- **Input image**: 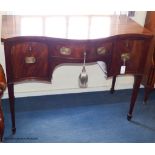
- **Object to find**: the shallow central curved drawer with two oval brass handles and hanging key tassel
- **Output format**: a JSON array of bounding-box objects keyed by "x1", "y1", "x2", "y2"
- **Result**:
[{"x1": 51, "y1": 40, "x2": 113, "y2": 60}]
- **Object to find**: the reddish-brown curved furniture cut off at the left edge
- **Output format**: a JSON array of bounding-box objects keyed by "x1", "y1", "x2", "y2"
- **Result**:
[{"x1": 0, "y1": 64, "x2": 6, "y2": 141}]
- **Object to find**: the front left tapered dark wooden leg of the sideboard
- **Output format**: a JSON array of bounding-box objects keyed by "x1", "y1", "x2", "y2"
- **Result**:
[{"x1": 8, "y1": 84, "x2": 16, "y2": 134}]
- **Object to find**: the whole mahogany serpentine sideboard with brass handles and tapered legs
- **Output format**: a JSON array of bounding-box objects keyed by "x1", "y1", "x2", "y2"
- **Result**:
[{"x1": 2, "y1": 16, "x2": 152, "y2": 133}]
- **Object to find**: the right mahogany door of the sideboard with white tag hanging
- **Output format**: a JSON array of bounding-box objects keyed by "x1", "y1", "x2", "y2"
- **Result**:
[{"x1": 112, "y1": 39, "x2": 148, "y2": 75}]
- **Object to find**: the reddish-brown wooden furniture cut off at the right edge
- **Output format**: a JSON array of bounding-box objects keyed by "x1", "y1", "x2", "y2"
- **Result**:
[{"x1": 142, "y1": 11, "x2": 155, "y2": 103}]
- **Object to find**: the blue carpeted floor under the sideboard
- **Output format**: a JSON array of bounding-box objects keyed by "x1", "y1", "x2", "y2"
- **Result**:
[{"x1": 3, "y1": 89, "x2": 155, "y2": 143}]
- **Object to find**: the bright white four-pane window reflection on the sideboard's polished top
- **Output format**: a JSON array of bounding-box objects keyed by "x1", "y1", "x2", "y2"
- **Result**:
[{"x1": 19, "y1": 15, "x2": 128, "y2": 39}]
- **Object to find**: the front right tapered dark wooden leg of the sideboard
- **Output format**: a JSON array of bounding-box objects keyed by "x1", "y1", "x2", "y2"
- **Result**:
[{"x1": 127, "y1": 75, "x2": 142, "y2": 121}]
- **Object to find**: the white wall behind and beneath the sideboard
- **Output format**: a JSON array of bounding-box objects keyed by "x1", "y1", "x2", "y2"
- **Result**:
[{"x1": 0, "y1": 12, "x2": 146, "y2": 98}]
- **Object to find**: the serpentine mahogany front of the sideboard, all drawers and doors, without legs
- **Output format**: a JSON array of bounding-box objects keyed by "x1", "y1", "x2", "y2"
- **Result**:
[{"x1": 3, "y1": 35, "x2": 151, "y2": 81}]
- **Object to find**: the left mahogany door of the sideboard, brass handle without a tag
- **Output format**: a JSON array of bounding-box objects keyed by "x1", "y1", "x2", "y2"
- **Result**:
[{"x1": 11, "y1": 42, "x2": 49, "y2": 82}]
